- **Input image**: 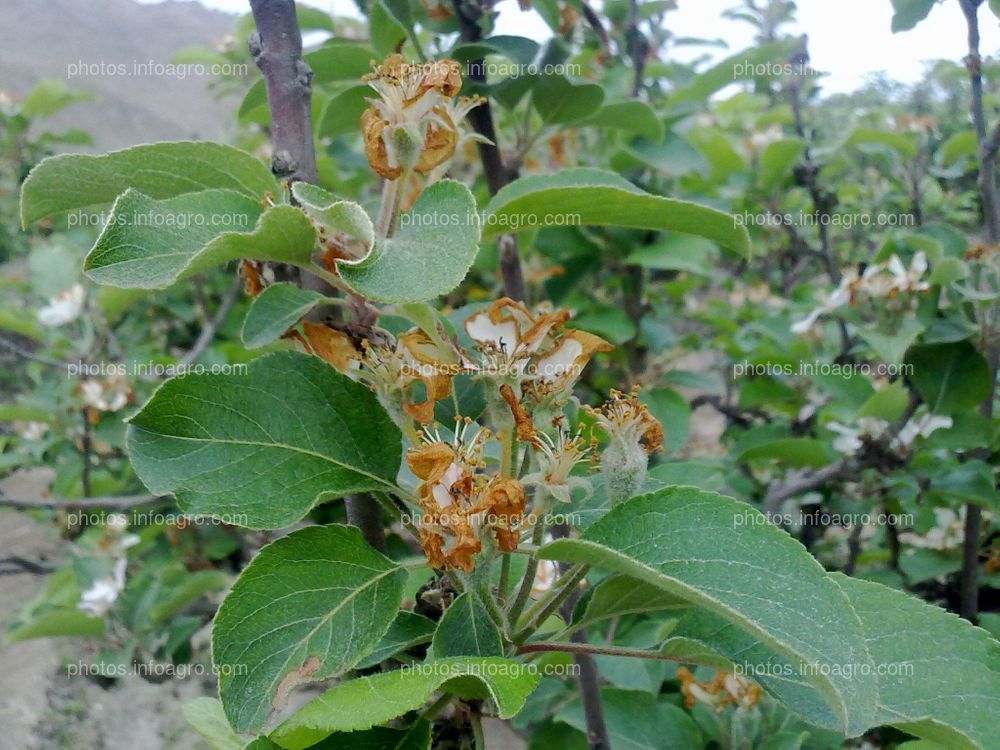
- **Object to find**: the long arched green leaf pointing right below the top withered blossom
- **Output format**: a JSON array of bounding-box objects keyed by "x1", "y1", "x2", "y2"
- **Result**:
[{"x1": 483, "y1": 168, "x2": 750, "y2": 257}]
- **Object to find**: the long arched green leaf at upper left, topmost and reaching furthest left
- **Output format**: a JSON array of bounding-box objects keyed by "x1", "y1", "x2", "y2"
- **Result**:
[{"x1": 21, "y1": 141, "x2": 278, "y2": 226}]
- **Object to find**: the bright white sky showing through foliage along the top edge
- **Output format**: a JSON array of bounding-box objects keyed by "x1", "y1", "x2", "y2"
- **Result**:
[{"x1": 142, "y1": 0, "x2": 1000, "y2": 93}]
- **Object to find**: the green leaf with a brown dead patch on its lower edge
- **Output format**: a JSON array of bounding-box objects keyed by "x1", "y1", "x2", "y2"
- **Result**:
[{"x1": 212, "y1": 525, "x2": 406, "y2": 732}]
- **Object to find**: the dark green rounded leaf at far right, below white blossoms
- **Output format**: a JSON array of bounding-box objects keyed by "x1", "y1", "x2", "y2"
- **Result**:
[{"x1": 906, "y1": 341, "x2": 991, "y2": 414}]
